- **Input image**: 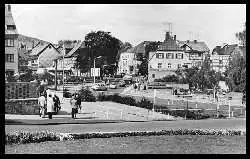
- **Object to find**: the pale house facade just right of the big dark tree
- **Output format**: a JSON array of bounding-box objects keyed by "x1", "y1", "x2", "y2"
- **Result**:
[{"x1": 117, "y1": 52, "x2": 140, "y2": 74}]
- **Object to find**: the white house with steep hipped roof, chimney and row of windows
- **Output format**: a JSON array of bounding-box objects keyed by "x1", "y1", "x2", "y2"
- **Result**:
[{"x1": 148, "y1": 32, "x2": 187, "y2": 82}]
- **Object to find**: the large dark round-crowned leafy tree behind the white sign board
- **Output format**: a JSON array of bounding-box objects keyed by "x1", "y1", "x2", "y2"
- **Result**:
[{"x1": 75, "y1": 31, "x2": 121, "y2": 74}]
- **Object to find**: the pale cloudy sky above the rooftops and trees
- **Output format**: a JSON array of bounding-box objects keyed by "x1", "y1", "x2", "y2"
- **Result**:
[{"x1": 12, "y1": 4, "x2": 246, "y2": 50}]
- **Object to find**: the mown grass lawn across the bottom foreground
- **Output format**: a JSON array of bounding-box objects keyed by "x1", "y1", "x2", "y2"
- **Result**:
[{"x1": 5, "y1": 135, "x2": 246, "y2": 154}]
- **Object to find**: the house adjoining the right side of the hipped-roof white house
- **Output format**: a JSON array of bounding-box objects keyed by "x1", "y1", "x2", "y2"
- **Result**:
[{"x1": 178, "y1": 40, "x2": 210, "y2": 67}]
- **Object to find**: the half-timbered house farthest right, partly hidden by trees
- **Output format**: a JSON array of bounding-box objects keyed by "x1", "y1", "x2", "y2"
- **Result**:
[{"x1": 210, "y1": 44, "x2": 246, "y2": 73}]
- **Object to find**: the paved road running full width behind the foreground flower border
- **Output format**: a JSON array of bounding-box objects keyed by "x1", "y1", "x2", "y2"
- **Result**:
[{"x1": 5, "y1": 119, "x2": 246, "y2": 133}]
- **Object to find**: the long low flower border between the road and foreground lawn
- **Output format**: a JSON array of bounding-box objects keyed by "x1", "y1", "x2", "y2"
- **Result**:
[{"x1": 5, "y1": 129, "x2": 246, "y2": 144}]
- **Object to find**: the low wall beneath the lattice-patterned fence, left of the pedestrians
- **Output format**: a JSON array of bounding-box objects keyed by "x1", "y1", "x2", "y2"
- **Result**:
[{"x1": 5, "y1": 98, "x2": 39, "y2": 115}]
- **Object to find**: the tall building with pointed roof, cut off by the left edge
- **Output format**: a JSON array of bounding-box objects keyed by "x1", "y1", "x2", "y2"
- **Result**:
[{"x1": 5, "y1": 5, "x2": 18, "y2": 76}]
